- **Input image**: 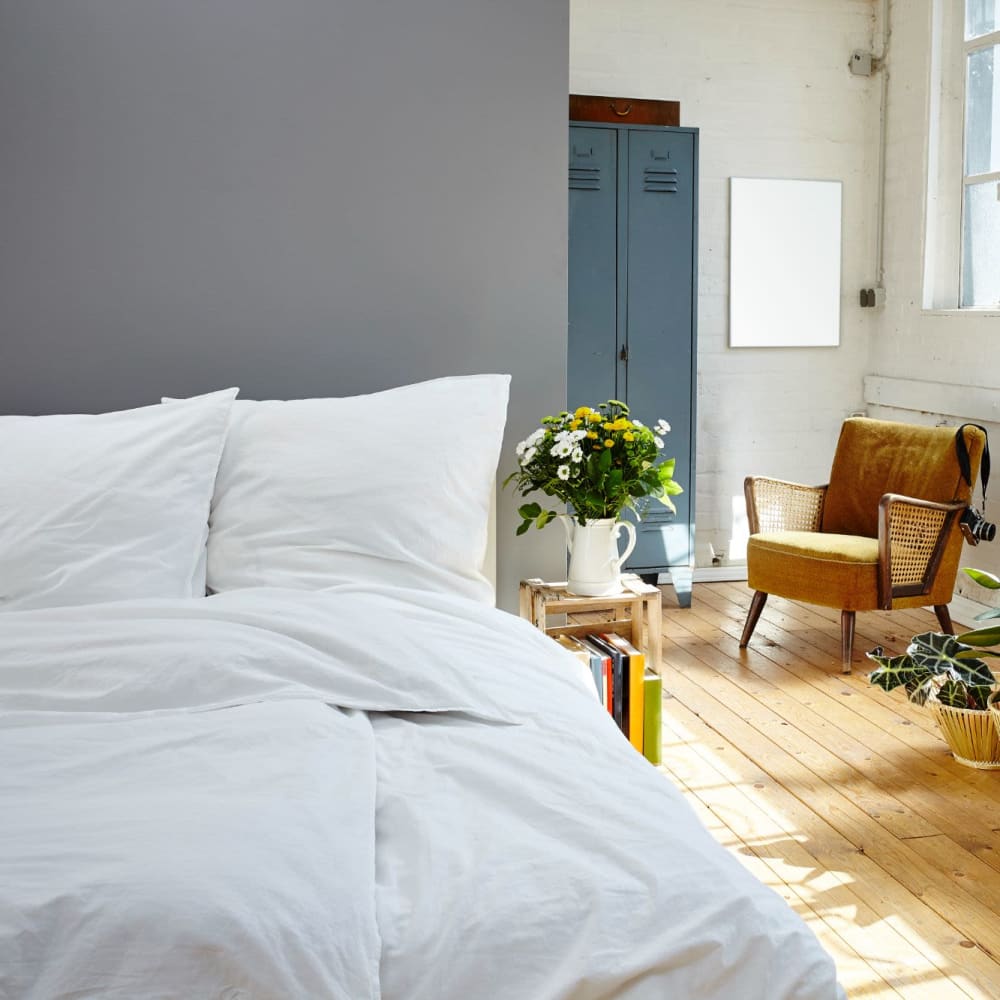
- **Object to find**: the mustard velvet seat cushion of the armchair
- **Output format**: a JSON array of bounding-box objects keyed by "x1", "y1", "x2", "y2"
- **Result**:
[{"x1": 747, "y1": 531, "x2": 878, "y2": 611}]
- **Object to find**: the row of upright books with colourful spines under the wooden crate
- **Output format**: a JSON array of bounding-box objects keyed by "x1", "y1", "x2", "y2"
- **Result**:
[{"x1": 556, "y1": 631, "x2": 663, "y2": 764}]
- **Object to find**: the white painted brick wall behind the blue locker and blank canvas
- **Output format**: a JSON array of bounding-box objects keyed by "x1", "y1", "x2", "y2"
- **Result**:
[{"x1": 570, "y1": 0, "x2": 878, "y2": 564}]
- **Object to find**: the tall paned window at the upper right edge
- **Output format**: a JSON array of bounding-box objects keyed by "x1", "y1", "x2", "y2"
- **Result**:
[{"x1": 959, "y1": 0, "x2": 1000, "y2": 307}]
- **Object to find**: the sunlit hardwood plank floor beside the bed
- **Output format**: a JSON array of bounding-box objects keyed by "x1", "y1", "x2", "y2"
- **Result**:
[{"x1": 648, "y1": 583, "x2": 1000, "y2": 1000}]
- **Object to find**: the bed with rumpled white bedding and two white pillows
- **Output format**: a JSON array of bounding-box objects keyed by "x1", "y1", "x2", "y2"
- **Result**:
[{"x1": 0, "y1": 375, "x2": 843, "y2": 1000}]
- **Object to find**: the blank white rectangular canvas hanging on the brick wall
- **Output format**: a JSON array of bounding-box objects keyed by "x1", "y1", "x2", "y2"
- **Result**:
[{"x1": 729, "y1": 177, "x2": 842, "y2": 347}]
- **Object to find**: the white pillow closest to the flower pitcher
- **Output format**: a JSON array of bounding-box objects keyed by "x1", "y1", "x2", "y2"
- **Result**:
[{"x1": 208, "y1": 375, "x2": 510, "y2": 603}]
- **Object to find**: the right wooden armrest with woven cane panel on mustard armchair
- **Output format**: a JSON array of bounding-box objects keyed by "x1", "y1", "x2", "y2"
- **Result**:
[{"x1": 878, "y1": 493, "x2": 966, "y2": 611}]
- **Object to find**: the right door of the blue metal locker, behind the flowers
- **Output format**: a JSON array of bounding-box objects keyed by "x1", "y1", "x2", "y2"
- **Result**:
[{"x1": 622, "y1": 130, "x2": 696, "y2": 584}]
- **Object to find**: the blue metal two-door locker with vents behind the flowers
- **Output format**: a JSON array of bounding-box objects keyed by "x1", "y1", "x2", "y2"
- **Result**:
[{"x1": 568, "y1": 124, "x2": 698, "y2": 607}]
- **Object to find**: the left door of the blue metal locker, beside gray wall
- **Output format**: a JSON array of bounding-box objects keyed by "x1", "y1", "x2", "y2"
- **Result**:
[{"x1": 567, "y1": 125, "x2": 619, "y2": 407}]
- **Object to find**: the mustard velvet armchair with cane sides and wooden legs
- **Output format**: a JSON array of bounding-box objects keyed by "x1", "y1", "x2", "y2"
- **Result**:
[{"x1": 740, "y1": 417, "x2": 986, "y2": 674}]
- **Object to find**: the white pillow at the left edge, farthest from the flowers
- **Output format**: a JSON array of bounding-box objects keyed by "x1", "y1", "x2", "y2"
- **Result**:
[{"x1": 0, "y1": 389, "x2": 239, "y2": 610}]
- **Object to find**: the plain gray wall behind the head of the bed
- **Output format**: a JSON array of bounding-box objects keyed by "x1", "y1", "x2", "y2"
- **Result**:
[{"x1": 0, "y1": 0, "x2": 568, "y2": 607}]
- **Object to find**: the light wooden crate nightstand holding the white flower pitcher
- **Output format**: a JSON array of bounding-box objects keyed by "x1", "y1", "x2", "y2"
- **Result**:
[{"x1": 521, "y1": 573, "x2": 661, "y2": 673}]
